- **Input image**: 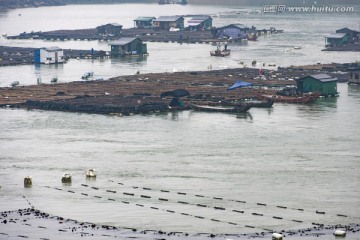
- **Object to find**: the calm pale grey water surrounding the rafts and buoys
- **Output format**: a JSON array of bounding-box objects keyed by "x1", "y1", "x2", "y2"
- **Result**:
[{"x1": 0, "y1": 4, "x2": 360, "y2": 233}]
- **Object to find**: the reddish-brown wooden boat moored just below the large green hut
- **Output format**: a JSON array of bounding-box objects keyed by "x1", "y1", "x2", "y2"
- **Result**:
[{"x1": 258, "y1": 93, "x2": 320, "y2": 104}]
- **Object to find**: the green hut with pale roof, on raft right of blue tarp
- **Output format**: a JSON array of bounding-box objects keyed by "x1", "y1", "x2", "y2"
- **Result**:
[{"x1": 296, "y1": 73, "x2": 338, "y2": 97}]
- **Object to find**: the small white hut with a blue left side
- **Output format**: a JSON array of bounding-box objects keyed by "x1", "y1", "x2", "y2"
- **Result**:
[{"x1": 34, "y1": 46, "x2": 65, "y2": 64}]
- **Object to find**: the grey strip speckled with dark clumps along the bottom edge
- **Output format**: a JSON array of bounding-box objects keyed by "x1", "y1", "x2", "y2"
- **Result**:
[{"x1": 0, "y1": 207, "x2": 360, "y2": 240}]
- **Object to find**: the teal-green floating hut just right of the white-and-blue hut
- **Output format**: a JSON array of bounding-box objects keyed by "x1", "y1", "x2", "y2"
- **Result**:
[{"x1": 109, "y1": 37, "x2": 148, "y2": 57}]
